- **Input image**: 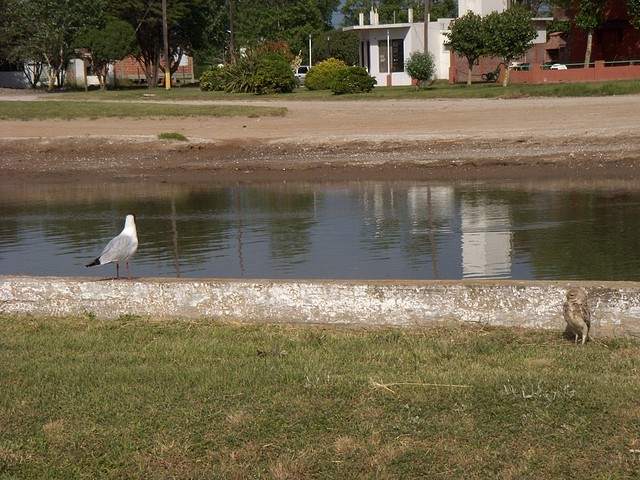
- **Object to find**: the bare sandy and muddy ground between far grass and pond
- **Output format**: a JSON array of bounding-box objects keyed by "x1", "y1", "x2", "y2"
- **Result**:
[{"x1": 0, "y1": 92, "x2": 640, "y2": 183}]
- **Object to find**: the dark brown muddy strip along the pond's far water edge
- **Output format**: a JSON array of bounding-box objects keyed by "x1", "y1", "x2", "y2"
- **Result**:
[{"x1": 0, "y1": 136, "x2": 640, "y2": 183}]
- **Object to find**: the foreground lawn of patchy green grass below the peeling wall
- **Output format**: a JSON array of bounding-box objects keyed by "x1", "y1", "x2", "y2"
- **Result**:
[{"x1": 0, "y1": 316, "x2": 640, "y2": 479}]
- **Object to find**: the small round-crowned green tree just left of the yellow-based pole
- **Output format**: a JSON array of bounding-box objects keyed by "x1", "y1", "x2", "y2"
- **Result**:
[{"x1": 74, "y1": 20, "x2": 136, "y2": 90}]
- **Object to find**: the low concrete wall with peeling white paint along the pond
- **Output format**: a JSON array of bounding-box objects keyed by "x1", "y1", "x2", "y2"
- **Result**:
[{"x1": 0, "y1": 276, "x2": 640, "y2": 336}]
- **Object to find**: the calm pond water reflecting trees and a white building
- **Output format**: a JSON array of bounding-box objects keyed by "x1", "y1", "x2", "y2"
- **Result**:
[{"x1": 0, "y1": 180, "x2": 640, "y2": 280}]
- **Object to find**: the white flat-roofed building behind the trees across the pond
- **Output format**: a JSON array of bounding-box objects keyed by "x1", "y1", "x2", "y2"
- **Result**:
[{"x1": 344, "y1": 0, "x2": 551, "y2": 86}]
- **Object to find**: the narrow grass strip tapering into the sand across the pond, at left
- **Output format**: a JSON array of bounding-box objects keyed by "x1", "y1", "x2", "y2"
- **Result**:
[{"x1": 0, "y1": 100, "x2": 286, "y2": 120}]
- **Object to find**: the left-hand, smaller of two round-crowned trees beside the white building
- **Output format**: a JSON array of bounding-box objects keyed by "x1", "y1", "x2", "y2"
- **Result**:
[{"x1": 445, "y1": 11, "x2": 486, "y2": 85}]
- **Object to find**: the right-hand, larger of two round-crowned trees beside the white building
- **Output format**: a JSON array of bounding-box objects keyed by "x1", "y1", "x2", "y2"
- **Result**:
[{"x1": 482, "y1": 5, "x2": 537, "y2": 87}]
